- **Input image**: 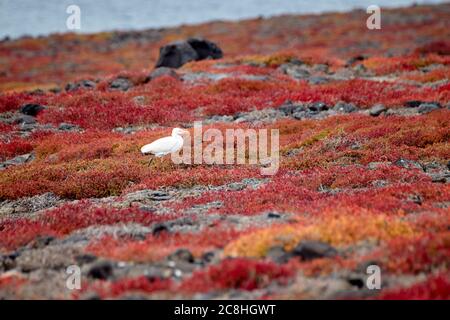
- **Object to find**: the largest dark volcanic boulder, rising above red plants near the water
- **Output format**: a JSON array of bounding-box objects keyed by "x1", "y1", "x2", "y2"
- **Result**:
[{"x1": 156, "y1": 38, "x2": 223, "y2": 68}]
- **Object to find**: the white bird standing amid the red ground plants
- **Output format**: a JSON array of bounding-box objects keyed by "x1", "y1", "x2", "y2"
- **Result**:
[{"x1": 141, "y1": 128, "x2": 189, "y2": 165}]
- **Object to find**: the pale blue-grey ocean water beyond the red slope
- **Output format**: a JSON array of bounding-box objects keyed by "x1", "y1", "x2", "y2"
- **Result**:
[{"x1": 0, "y1": 0, "x2": 444, "y2": 38}]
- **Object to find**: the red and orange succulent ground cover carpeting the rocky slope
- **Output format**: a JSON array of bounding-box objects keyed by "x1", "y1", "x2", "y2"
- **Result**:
[{"x1": 0, "y1": 4, "x2": 450, "y2": 299}]
